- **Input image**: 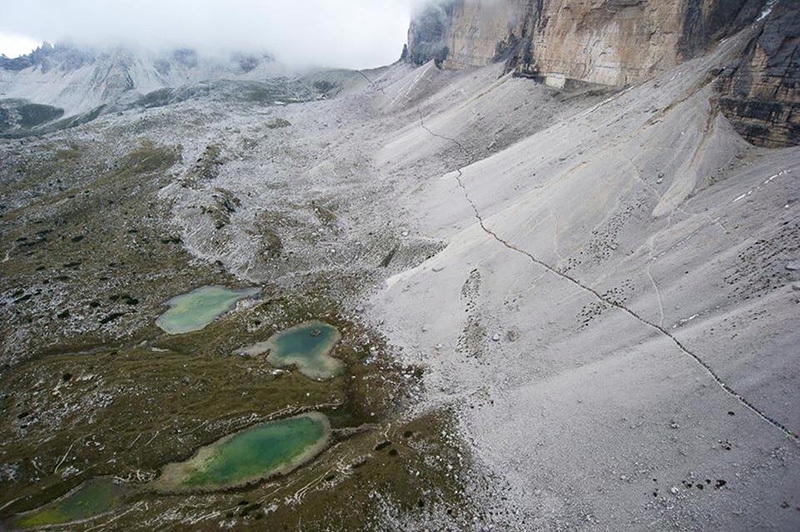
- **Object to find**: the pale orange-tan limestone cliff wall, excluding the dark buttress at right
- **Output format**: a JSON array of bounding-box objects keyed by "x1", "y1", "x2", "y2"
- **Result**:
[{"x1": 409, "y1": 0, "x2": 767, "y2": 85}]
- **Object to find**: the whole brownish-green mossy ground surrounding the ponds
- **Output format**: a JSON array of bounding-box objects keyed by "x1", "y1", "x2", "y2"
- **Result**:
[{"x1": 0, "y1": 138, "x2": 476, "y2": 530}]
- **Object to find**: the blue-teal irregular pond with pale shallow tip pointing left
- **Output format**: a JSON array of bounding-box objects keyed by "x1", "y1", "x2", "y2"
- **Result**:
[{"x1": 234, "y1": 321, "x2": 344, "y2": 379}]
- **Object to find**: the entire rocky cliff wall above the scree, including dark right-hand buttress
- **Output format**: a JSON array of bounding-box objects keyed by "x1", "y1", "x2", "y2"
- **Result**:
[{"x1": 405, "y1": 0, "x2": 800, "y2": 147}]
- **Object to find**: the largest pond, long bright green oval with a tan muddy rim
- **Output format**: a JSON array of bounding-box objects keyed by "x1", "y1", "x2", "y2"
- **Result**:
[{"x1": 155, "y1": 412, "x2": 330, "y2": 491}]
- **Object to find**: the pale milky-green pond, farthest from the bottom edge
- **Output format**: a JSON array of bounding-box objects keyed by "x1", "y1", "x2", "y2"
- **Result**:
[{"x1": 156, "y1": 286, "x2": 259, "y2": 334}]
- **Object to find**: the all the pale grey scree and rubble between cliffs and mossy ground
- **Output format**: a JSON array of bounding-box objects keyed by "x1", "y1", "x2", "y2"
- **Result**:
[{"x1": 1, "y1": 23, "x2": 800, "y2": 530}]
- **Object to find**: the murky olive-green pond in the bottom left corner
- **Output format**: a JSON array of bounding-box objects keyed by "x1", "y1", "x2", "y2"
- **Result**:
[{"x1": 14, "y1": 478, "x2": 125, "y2": 528}]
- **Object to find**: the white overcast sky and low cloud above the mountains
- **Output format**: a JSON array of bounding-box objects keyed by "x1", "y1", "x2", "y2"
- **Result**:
[{"x1": 0, "y1": 0, "x2": 432, "y2": 68}]
